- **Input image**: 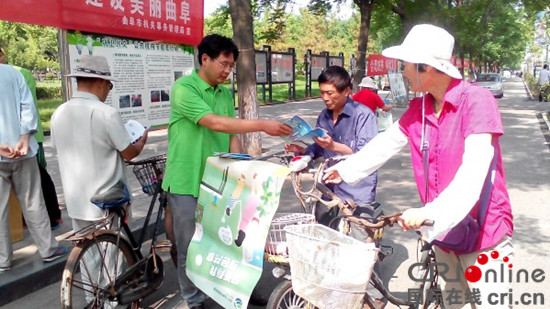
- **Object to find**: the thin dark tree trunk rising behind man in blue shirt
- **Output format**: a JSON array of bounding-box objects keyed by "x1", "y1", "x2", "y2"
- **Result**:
[{"x1": 350, "y1": 0, "x2": 374, "y2": 91}]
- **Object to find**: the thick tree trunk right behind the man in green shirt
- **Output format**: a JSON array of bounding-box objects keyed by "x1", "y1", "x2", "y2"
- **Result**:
[{"x1": 229, "y1": 0, "x2": 262, "y2": 156}]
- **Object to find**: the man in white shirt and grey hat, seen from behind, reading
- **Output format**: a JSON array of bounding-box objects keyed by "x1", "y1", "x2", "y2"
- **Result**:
[{"x1": 51, "y1": 56, "x2": 148, "y2": 230}]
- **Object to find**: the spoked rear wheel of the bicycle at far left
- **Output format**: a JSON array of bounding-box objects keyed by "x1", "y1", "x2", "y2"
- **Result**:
[{"x1": 61, "y1": 230, "x2": 138, "y2": 309}]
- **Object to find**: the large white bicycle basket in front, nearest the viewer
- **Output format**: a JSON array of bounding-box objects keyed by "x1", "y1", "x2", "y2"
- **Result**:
[{"x1": 285, "y1": 224, "x2": 378, "y2": 309}]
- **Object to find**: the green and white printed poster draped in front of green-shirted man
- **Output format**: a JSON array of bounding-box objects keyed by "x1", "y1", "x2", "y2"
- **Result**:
[{"x1": 187, "y1": 157, "x2": 290, "y2": 309}]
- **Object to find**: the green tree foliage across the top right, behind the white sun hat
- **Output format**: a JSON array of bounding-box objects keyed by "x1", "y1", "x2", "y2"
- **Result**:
[{"x1": 206, "y1": 0, "x2": 550, "y2": 70}]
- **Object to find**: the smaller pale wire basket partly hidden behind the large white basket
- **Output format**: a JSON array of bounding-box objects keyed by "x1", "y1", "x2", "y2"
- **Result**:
[{"x1": 265, "y1": 213, "x2": 315, "y2": 257}]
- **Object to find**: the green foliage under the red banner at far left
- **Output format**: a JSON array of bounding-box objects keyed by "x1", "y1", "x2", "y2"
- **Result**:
[{"x1": 0, "y1": 21, "x2": 59, "y2": 70}]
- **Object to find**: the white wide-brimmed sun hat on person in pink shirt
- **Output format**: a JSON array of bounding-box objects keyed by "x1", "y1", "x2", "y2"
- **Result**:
[{"x1": 382, "y1": 24, "x2": 462, "y2": 79}]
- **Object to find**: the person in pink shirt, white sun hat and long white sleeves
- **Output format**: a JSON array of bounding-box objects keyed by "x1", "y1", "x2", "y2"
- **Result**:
[{"x1": 324, "y1": 25, "x2": 513, "y2": 308}]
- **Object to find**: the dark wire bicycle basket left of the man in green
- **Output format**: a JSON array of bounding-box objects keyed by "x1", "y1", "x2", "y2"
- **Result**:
[{"x1": 131, "y1": 154, "x2": 166, "y2": 195}]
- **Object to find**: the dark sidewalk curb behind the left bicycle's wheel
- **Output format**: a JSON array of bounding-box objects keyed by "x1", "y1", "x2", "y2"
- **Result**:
[{"x1": 0, "y1": 214, "x2": 165, "y2": 307}]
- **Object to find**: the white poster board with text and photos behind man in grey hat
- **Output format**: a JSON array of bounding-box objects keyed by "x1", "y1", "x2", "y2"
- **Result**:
[{"x1": 67, "y1": 31, "x2": 194, "y2": 127}]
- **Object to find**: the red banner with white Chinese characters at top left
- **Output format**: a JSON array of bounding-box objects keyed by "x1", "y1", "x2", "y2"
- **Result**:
[{"x1": 0, "y1": 0, "x2": 204, "y2": 46}]
